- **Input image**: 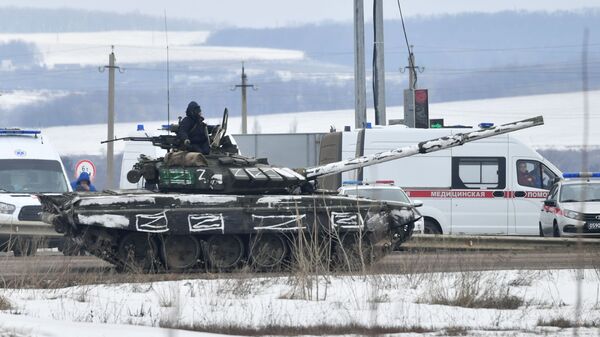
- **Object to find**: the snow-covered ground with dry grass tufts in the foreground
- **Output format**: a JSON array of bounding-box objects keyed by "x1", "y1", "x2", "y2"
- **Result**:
[{"x1": 0, "y1": 270, "x2": 600, "y2": 336}]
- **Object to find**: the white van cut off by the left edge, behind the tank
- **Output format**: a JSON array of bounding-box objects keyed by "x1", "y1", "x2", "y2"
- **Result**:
[{"x1": 0, "y1": 129, "x2": 71, "y2": 256}]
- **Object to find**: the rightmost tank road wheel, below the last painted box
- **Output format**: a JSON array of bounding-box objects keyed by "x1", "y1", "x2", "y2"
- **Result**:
[{"x1": 334, "y1": 233, "x2": 374, "y2": 271}]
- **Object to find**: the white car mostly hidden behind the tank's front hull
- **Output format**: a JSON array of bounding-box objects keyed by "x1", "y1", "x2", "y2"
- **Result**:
[{"x1": 338, "y1": 180, "x2": 425, "y2": 233}]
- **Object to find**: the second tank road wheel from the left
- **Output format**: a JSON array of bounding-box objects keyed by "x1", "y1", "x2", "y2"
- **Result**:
[{"x1": 162, "y1": 235, "x2": 200, "y2": 270}]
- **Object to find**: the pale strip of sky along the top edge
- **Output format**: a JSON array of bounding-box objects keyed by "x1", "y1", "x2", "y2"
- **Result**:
[{"x1": 0, "y1": 0, "x2": 600, "y2": 27}]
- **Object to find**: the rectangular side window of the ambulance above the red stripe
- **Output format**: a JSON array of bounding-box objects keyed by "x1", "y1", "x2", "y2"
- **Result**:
[{"x1": 452, "y1": 157, "x2": 506, "y2": 189}]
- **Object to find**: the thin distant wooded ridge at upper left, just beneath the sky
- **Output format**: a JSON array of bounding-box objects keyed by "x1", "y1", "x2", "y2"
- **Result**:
[{"x1": 0, "y1": 7, "x2": 207, "y2": 33}]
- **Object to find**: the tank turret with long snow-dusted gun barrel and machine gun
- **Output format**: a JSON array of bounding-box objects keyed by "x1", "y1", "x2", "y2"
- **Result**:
[{"x1": 120, "y1": 110, "x2": 544, "y2": 194}]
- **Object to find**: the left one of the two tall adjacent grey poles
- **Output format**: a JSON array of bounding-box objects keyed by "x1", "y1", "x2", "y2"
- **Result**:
[{"x1": 354, "y1": 0, "x2": 367, "y2": 129}]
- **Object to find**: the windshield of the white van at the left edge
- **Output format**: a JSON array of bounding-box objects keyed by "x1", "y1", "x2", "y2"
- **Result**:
[{"x1": 0, "y1": 159, "x2": 68, "y2": 193}]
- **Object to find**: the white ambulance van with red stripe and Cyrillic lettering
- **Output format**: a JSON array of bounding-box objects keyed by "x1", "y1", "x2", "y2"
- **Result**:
[{"x1": 320, "y1": 125, "x2": 561, "y2": 235}]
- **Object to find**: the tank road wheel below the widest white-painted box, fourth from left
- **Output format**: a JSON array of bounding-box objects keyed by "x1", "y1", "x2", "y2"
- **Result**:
[{"x1": 250, "y1": 234, "x2": 288, "y2": 270}]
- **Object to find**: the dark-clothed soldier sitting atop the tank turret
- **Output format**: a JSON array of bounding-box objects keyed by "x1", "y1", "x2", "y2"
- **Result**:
[{"x1": 177, "y1": 101, "x2": 215, "y2": 154}]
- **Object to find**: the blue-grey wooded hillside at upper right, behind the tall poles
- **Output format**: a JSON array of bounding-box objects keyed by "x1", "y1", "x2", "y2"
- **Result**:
[{"x1": 207, "y1": 9, "x2": 600, "y2": 71}]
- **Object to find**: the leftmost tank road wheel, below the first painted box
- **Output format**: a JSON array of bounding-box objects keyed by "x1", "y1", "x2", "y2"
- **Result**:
[{"x1": 119, "y1": 233, "x2": 158, "y2": 272}]
